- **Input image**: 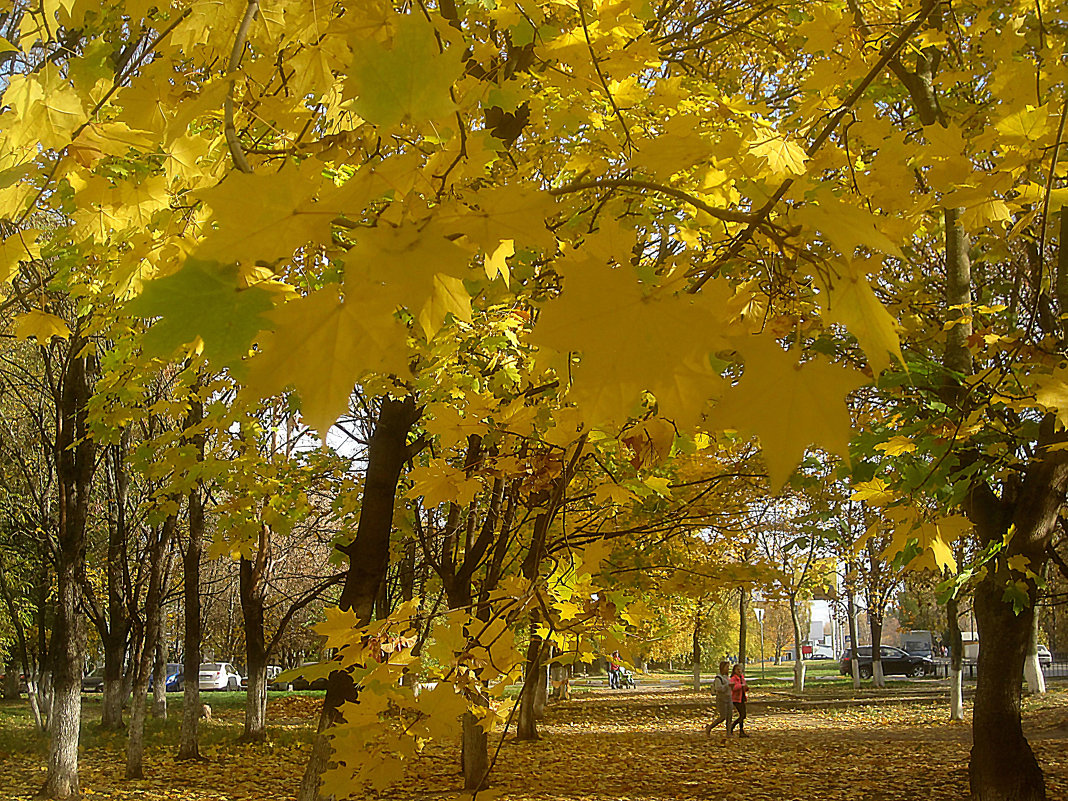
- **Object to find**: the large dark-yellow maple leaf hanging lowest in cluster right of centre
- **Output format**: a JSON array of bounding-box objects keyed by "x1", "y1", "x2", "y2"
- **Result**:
[{"x1": 711, "y1": 335, "x2": 868, "y2": 491}]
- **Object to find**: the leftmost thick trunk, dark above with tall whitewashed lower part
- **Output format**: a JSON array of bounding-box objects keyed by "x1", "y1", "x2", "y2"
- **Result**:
[{"x1": 40, "y1": 334, "x2": 96, "y2": 799}]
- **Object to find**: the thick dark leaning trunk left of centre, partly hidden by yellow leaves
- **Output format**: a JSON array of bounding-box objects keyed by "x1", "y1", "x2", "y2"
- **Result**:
[{"x1": 297, "y1": 396, "x2": 420, "y2": 801}]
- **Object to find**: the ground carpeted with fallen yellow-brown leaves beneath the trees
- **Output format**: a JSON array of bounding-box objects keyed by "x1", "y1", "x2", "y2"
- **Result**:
[{"x1": 0, "y1": 687, "x2": 1068, "y2": 801}]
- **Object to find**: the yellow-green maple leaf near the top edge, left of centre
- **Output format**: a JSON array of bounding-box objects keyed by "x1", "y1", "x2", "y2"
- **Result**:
[{"x1": 345, "y1": 14, "x2": 464, "y2": 127}]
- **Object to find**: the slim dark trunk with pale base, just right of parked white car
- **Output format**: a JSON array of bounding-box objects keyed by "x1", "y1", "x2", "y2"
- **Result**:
[{"x1": 240, "y1": 523, "x2": 271, "y2": 742}]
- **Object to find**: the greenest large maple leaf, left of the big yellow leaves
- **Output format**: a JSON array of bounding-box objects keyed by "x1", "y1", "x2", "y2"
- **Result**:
[{"x1": 126, "y1": 258, "x2": 274, "y2": 364}]
